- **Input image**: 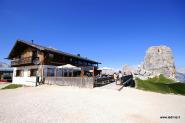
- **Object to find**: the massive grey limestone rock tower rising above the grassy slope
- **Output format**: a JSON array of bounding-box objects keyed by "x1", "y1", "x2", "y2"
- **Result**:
[{"x1": 143, "y1": 46, "x2": 176, "y2": 79}]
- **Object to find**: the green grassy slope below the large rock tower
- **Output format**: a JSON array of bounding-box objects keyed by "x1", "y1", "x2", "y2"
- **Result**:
[{"x1": 136, "y1": 75, "x2": 185, "y2": 95}]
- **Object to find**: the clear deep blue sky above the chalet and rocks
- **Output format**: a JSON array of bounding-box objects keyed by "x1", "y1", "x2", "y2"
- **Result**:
[{"x1": 0, "y1": 0, "x2": 185, "y2": 68}]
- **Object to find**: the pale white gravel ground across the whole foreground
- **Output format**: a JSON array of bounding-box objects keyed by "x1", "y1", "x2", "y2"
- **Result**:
[{"x1": 0, "y1": 85, "x2": 185, "y2": 123}]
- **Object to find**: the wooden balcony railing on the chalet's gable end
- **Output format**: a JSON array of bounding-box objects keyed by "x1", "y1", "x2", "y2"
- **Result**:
[{"x1": 11, "y1": 57, "x2": 33, "y2": 66}]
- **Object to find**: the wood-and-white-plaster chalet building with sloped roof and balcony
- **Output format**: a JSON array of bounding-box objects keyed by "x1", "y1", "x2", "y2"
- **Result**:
[{"x1": 8, "y1": 40, "x2": 100, "y2": 86}]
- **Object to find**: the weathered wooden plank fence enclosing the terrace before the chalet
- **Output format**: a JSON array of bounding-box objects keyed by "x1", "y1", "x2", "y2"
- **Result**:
[{"x1": 44, "y1": 77, "x2": 94, "y2": 88}]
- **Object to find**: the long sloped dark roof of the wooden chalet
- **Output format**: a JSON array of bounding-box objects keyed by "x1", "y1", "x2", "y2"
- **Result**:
[{"x1": 8, "y1": 40, "x2": 101, "y2": 64}]
